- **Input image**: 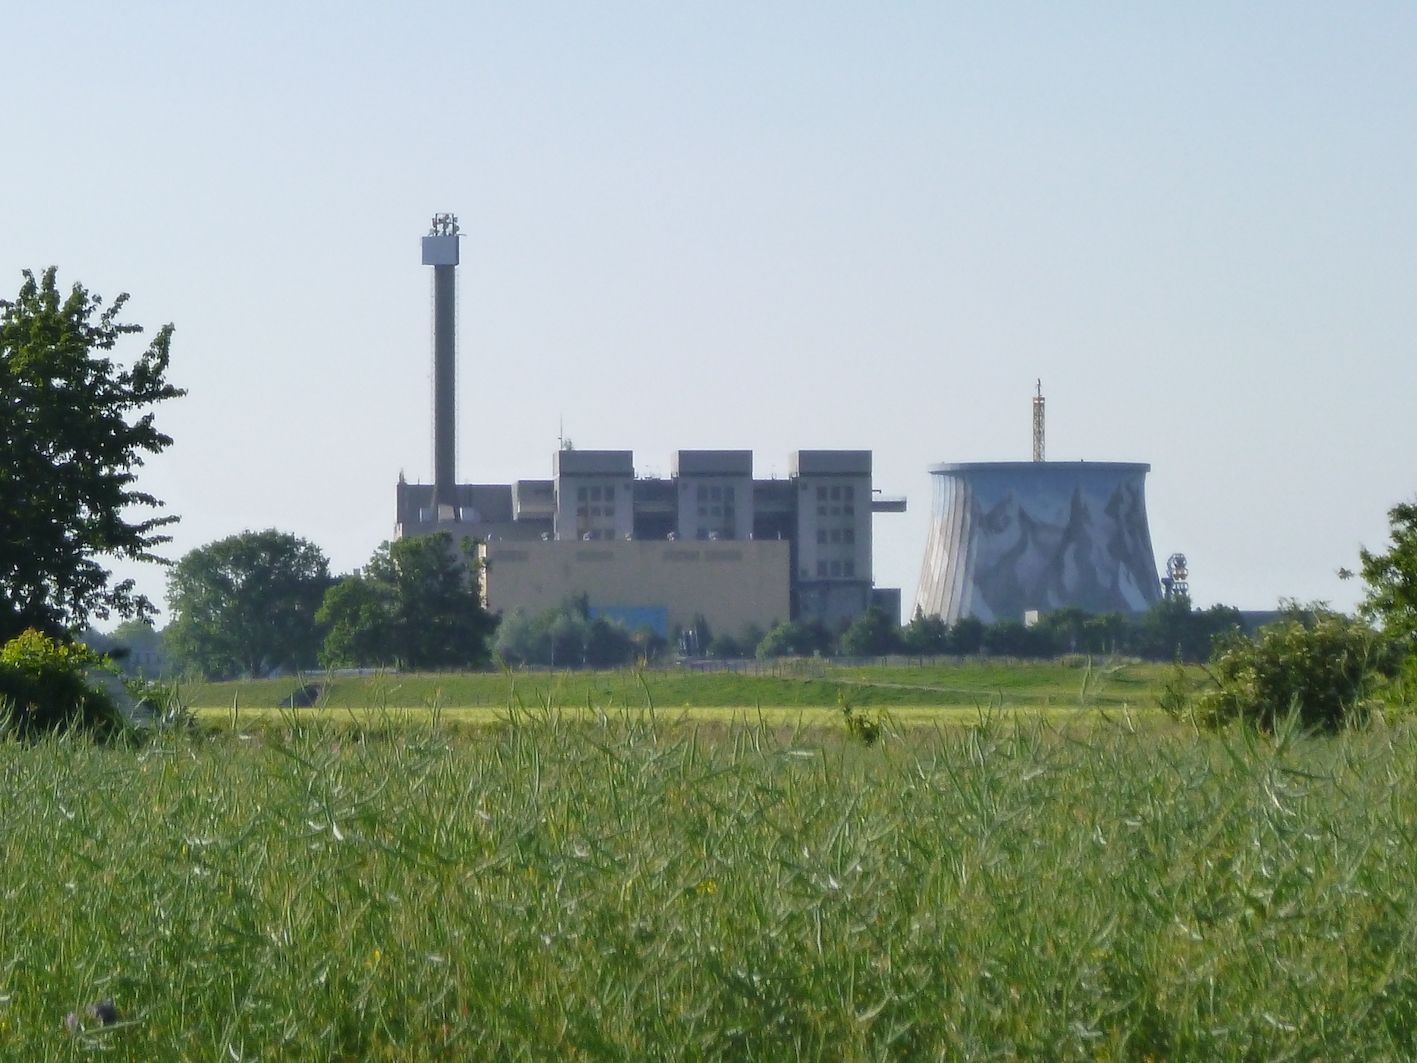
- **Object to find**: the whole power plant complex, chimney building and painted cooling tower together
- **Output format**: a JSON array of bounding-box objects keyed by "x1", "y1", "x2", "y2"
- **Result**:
[{"x1": 397, "y1": 214, "x2": 1161, "y2": 634}]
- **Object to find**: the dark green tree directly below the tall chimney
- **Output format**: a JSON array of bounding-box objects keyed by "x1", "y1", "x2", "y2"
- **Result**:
[{"x1": 316, "y1": 532, "x2": 497, "y2": 669}]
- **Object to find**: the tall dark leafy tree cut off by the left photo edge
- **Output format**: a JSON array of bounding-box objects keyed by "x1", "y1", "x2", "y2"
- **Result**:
[{"x1": 0, "y1": 268, "x2": 183, "y2": 642}]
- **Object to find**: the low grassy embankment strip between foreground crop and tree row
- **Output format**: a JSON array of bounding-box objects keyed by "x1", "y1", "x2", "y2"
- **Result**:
[{"x1": 183, "y1": 659, "x2": 1169, "y2": 723}]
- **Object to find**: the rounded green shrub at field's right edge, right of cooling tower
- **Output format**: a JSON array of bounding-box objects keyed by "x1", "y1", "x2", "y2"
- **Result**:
[{"x1": 1196, "y1": 607, "x2": 1400, "y2": 731}]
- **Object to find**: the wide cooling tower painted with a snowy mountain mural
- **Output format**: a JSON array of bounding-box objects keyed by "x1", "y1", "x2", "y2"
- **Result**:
[{"x1": 915, "y1": 462, "x2": 1161, "y2": 624}]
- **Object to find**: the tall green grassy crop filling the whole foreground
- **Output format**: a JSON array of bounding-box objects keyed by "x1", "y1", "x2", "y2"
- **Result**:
[{"x1": 0, "y1": 712, "x2": 1417, "y2": 1060}]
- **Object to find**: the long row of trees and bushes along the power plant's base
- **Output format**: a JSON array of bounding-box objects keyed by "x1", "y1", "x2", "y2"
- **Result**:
[{"x1": 82, "y1": 529, "x2": 1297, "y2": 677}]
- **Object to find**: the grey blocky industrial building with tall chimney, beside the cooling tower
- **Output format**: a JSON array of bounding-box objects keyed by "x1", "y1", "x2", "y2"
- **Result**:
[{"x1": 395, "y1": 214, "x2": 905, "y2": 635}]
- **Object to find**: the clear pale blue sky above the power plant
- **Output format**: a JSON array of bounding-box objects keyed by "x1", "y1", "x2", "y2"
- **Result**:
[{"x1": 0, "y1": 0, "x2": 1417, "y2": 623}]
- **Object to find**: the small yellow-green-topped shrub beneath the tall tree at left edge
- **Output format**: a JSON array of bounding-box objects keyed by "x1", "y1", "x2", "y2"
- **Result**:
[{"x1": 0, "y1": 629, "x2": 123, "y2": 738}]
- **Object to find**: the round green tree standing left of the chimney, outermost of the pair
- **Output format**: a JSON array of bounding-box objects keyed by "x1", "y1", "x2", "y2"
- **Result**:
[{"x1": 167, "y1": 529, "x2": 332, "y2": 677}]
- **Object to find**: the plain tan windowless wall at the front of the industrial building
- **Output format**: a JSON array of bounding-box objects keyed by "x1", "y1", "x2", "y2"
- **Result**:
[{"x1": 480, "y1": 540, "x2": 789, "y2": 634}]
